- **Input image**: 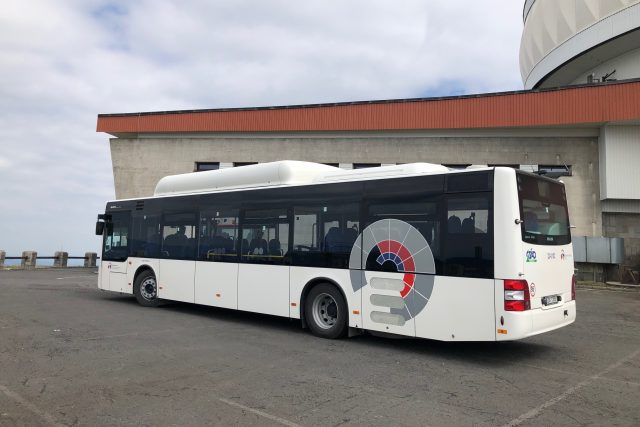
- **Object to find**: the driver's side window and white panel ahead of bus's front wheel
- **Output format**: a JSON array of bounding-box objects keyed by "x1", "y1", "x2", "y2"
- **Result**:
[{"x1": 100, "y1": 211, "x2": 131, "y2": 293}]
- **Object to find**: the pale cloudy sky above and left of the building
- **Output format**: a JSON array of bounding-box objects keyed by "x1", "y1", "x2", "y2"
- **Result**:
[{"x1": 0, "y1": 0, "x2": 524, "y2": 255}]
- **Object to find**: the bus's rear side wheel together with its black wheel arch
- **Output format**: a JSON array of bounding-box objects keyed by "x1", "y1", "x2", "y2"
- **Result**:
[{"x1": 300, "y1": 277, "x2": 349, "y2": 339}]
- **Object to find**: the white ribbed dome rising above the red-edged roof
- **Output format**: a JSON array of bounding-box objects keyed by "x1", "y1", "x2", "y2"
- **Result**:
[{"x1": 520, "y1": 0, "x2": 640, "y2": 89}]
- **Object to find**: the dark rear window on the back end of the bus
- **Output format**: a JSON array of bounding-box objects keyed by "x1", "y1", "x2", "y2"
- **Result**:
[{"x1": 518, "y1": 173, "x2": 571, "y2": 245}]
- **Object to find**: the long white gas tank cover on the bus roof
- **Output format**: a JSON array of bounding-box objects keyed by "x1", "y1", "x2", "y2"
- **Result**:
[{"x1": 154, "y1": 160, "x2": 448, "y2": 196}]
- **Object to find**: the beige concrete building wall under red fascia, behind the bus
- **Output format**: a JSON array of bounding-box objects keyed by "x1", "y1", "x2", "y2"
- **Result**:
[{"x1": 111, "y1": 130, "x2": 602, "y2": 236}]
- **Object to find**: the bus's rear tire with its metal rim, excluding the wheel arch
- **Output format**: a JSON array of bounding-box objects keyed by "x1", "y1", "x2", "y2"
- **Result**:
[{"x1": 304, "y1": 283, "x2": 349, "y2": 339}]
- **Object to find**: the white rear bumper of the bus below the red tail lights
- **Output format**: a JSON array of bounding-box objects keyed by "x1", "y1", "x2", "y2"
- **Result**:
[{"x1": 496, "y1": 301, "x2": 576, "y2": 341}]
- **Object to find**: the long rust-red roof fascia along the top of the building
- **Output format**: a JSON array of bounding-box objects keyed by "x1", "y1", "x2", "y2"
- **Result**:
[{"x1": 97, "y1": 81, "x2": 640, "y2": 134}]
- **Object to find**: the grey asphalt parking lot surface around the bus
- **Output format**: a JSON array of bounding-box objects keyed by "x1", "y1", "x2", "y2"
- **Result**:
[{"x1": 0, "y1": 268, "x2": 640, "y2": 426}]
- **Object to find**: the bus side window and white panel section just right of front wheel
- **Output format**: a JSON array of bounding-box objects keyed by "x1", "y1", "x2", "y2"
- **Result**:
[{"x1": 158, "y1": 212, "x2": 197, "y2": 302}]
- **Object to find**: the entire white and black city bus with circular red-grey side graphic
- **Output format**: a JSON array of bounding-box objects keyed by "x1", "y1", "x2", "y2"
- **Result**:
[{"x1": 96, "y1": 161, "x2": 576, "y2": 341}]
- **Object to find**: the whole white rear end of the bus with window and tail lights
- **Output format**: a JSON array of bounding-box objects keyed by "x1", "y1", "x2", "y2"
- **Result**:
[{"x1": 494, "y1": 168, "x2": 576, "y2": 341}]
